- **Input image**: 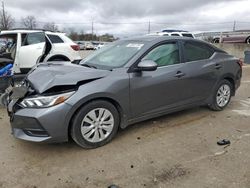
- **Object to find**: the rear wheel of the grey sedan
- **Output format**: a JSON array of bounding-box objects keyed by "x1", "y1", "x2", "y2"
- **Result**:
[{"x1": 209, "y1": 80, "x2": 233, "y2": 111}]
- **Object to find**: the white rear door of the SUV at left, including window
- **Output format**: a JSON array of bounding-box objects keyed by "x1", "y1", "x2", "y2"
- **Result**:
[{"x1": 18, "y1": 32, "x2": 45, "y2": 73}]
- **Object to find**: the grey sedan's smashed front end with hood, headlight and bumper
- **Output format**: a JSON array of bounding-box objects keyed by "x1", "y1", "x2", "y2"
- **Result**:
[{"x1": 6, "y1": 63, "x2": 109, "y2": 143}]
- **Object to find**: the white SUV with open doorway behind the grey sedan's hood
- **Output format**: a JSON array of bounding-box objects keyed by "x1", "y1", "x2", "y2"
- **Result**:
[{"x1": 0, "y1": 30, "x2": 81, "y2": 74}]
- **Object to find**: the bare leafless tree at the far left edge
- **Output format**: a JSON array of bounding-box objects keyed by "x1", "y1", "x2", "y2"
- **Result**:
[{"x1": 0, "y1": 2, "x2": 15, "y2": 30}]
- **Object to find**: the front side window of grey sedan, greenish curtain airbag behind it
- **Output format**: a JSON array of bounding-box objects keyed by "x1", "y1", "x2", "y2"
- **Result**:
[{"x1": 143, "y1": 43, "x2": 180, "y2": 67}]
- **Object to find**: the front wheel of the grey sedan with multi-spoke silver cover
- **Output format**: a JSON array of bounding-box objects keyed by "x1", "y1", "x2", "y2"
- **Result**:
[{"x1": 71, "y1": 100, "x2": 120, "y2": 149}]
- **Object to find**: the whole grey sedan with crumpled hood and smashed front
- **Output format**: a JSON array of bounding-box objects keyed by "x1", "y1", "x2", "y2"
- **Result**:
[{"x1": 5, "y1": 36, "x2": 242, "y2": 148}]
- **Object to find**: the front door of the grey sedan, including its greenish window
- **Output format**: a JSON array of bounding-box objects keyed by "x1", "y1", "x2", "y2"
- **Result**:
[{"x1": 129, "y1": 42, "x2": 187, "y2": 118}]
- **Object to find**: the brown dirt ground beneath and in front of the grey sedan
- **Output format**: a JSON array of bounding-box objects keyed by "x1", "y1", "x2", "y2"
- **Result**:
[{"x1": 0, "y1": 62, "x2": 250, "y2": 188}]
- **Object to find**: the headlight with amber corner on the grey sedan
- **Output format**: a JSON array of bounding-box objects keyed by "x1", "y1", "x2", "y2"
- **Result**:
[{"x1": 20, "y1": 91, "x2": 74, "y2": 108}]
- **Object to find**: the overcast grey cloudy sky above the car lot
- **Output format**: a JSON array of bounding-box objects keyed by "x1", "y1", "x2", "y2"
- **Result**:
[{"x1": 4, "y1": 0, "x2": 250, "y2": 37}]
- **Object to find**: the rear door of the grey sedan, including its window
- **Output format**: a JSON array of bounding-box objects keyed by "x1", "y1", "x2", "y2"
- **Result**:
[{"x1": 183, "y1": 40, "x2": 223, "y2": 102}]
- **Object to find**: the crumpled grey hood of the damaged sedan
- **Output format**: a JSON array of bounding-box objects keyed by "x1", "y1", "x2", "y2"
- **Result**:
[{"x1": 26, "y1": 62, "x2": 110, "y2": 93}]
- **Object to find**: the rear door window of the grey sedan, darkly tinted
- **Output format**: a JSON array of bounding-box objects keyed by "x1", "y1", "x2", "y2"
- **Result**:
[{"x1": 184, "y1": 42, "x2": 214, "y2": 62}]
